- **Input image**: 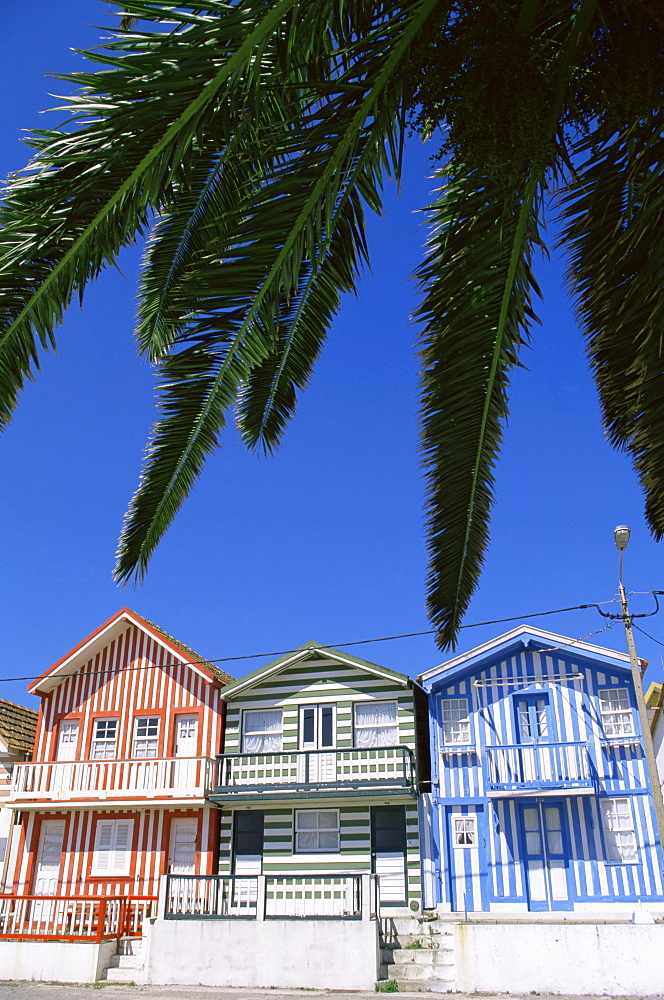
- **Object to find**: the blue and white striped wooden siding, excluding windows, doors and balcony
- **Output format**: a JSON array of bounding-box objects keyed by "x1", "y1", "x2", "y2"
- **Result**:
[{"x1": 423, "y1": 649, "x2": 664, "y2": 911}]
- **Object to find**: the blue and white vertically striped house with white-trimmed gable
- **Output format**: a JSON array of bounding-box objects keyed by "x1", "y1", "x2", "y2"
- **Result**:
[{"x1": 418, "y1": 626, "x2": 664, "y2": 913}]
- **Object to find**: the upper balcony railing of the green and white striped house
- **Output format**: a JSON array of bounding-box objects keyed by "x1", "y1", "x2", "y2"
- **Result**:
[{"x1": 215, "y1": 746, "x2": 415, "y2": 796}]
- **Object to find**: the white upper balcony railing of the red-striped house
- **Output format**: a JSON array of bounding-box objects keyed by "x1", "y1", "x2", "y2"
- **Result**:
[{"x1": 9, "y1": 757, "x2": 216, "y2": 802}]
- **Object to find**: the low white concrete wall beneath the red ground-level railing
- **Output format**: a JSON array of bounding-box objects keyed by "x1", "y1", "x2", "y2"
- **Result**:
[{"x1": 0, "y1": 941, "x2": 115, "y2": 983}]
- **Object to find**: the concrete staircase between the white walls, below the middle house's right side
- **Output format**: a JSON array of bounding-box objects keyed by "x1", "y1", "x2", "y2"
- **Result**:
[{"x1": 377, "y1": 917, "x2": 456, "y2": 993}]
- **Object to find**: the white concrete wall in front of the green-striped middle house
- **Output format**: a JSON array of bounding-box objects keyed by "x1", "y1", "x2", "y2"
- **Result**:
[{"x1": 143, "y1": 918, "x2": 379, "y2": 990}]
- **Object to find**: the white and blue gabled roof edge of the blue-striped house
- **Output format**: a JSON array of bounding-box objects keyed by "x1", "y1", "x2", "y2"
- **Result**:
[{"x1": 417, "y1": 625, "x2": 630, "y2": 690}]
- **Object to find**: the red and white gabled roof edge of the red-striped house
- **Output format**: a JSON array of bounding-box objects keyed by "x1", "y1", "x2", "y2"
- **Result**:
[{"x1": 28, "y1": 608, "x2": 233, "y2": 694}]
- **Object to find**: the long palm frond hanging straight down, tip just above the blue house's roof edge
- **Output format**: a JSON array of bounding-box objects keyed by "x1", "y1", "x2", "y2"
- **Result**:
[{"x1": 416, "y1": 167, "x2": 544, "y2": 647}]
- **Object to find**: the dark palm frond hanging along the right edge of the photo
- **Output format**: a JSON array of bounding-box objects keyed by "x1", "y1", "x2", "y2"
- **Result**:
[{"x1": 561, "y1": 116, "x2": 664, "y2": 540}]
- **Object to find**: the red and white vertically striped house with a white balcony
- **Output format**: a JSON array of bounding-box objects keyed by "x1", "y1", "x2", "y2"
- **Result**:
[{"x1": 9, "y1": 608, "x2": 232, "y2": 898}]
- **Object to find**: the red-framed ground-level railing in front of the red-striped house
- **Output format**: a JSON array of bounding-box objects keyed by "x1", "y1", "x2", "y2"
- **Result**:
[{"x1": 0, "y1": 894, "x2": 157, "y2": 942}]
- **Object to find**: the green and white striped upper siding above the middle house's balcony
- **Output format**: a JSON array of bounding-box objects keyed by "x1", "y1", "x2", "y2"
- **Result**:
[{"x1": 224, "y1": 660, "x2": 415, "y2": 754}]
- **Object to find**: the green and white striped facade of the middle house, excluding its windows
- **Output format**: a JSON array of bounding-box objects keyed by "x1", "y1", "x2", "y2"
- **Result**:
[{"x1": 212, "y1": 643, "x2": 426, "y2": 907}]
